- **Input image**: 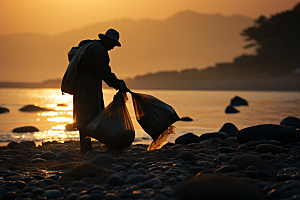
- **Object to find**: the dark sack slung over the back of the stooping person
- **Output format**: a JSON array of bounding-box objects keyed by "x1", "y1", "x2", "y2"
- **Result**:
[{"x1": 61, "y1": 42, "x2": 93, "y2": 94}]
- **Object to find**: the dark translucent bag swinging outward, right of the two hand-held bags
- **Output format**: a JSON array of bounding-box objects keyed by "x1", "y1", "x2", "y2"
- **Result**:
[{"x1": 130, "y1": 92, "x2": 180, "y2": 141}]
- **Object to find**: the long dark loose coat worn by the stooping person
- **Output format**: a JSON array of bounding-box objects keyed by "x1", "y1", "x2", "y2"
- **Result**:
[{"x1": 73, "y1": 41, "x2": 125, "y2": 130}]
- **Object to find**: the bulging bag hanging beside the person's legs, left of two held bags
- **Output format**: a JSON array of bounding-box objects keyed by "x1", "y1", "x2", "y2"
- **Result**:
[{"x1": 86, "y1": 92, "x2": 135, "y2": 150}]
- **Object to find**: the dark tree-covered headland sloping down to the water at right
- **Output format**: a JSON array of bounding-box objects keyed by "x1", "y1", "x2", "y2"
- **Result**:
[{"x1": 133, "y1": 3, "x2": 300, "y2": 85}]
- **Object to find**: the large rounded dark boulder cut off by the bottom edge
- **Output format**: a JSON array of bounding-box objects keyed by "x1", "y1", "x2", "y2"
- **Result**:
[{"x1": 174, "y1": 174, "x2": 262, "y2": 200}]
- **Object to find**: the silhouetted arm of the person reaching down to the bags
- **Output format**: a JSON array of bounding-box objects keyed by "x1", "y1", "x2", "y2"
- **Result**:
[{"x1": 91, "y1": 45, "x2": 127, "y2": 91}]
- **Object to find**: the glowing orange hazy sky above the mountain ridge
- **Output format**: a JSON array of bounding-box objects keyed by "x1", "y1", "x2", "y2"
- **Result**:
[{"x1": 0, "y1": 0, "x2": 300, "y2": 35}]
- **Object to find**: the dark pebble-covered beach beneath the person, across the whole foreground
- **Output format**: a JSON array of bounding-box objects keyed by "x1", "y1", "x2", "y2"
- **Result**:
[{"x1": 0, "y1": 125, "x2": 300, "y2": 200}]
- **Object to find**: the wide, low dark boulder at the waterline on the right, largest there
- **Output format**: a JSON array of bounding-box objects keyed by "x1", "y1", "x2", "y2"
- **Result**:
[{"x1": 237, "y1": 124, "x2": 296, "y2": 144}]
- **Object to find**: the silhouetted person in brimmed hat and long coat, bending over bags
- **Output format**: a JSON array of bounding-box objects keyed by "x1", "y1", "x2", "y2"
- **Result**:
[{"x1": 69, "y1": 29, "x2": 128, "y2": 154}]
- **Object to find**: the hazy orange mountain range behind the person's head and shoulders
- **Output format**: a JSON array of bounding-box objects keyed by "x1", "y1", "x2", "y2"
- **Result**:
[{"x1": 0, "y1": 11, "x2": 253, "y2": 82}]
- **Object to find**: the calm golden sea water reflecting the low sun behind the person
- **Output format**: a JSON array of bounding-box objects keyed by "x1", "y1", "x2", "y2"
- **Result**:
[{"x1": 0, "y1": 88, "x2": 300, "y2": 146}]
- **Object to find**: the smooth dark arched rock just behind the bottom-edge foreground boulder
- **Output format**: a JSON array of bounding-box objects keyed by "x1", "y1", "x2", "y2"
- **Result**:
[{"x1": 227, "y1": 155, "x2": 276, "y2": 176}]
